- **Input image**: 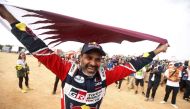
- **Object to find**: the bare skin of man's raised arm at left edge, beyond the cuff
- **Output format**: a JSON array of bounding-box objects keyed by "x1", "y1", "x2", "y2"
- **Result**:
[{"x1": 0, "y1": 4, "x2": 17, "y2": 24}]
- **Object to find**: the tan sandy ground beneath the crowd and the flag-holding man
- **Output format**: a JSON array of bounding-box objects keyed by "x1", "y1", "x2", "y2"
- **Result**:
[{"x1": 0, "y1": 52, "x2": 190, "y2": 109}]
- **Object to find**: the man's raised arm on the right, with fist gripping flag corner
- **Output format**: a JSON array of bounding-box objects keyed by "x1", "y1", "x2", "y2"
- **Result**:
[{"x1": 106, "y1": 44, "x2": 168, "y2": 85}]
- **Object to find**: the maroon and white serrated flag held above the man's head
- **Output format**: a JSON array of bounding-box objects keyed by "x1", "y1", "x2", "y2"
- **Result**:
[{"x1": 1, "y1": 3, "x2": 167, "y2": 45}]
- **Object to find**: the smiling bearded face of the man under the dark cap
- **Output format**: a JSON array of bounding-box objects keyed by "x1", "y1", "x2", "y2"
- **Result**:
[{"x1": 80, "y1": 51, "x2": 102, "y2": 74}]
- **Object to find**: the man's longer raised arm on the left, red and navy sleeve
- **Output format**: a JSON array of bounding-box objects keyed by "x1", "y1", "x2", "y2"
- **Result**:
[{"x1": 0, "y1": 4, "x2": 71, "y2": 80}]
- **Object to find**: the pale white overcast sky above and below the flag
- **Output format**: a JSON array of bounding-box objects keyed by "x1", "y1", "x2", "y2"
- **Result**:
[{"x1": 0, "y1": 0, "x2": 190, "y2": 60}]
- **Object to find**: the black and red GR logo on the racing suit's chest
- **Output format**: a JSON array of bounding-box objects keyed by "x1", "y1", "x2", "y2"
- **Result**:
[{"x1": 68, "y1": 88, "x2": 87, "y2": 101}]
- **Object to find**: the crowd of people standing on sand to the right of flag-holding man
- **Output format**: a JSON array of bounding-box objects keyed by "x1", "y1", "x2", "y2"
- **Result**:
[{"x1": 99, "y1": 56, "x2": 190, "y2": 108}]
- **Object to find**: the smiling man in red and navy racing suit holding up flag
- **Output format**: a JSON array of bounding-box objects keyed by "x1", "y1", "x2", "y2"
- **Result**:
[{"x1": 0, "y1": 5, "x2": 168, "y2": 109}]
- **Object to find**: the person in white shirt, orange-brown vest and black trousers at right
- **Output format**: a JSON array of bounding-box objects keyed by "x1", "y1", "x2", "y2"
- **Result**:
[{"x1": 160, "y1": 63, "x2": 181, "y2": 108}]
